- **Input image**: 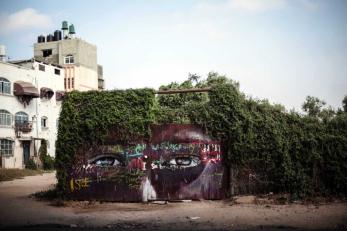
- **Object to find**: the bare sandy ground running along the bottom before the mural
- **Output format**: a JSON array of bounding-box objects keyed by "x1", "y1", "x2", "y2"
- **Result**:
[{"x1": 0, "y1": 173, "x2": 347, "y2": 230}]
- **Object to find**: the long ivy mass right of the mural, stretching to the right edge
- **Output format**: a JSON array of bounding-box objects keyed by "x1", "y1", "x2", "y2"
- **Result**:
[{"x1": 158, "y1": 72, "x2": 347, "y2": 198}]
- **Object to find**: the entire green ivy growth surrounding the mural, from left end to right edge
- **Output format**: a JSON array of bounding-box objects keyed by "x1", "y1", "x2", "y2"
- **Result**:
[{"x1": 56, "y1": 73, "x2": 347, "y2": 197}]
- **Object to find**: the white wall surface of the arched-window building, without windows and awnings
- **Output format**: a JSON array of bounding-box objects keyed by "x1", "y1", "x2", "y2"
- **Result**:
[{"x1": 0, "y1": 59, "x2": 64, "y2": 168}]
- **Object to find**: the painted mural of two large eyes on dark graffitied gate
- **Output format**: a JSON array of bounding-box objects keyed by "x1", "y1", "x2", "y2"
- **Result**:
[{"x1": 69, "y1": 124, "x2": 223, "y2": 201}]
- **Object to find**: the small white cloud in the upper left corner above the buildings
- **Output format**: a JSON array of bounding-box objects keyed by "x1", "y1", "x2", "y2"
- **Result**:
[{"x1": 0, "y1": 8, "x2": 53, "y2": 33}]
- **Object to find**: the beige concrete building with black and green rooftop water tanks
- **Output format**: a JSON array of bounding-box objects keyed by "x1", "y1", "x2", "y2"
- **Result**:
[{"x1": 34, "y1": 21, "x2": 104, "y2": 91}]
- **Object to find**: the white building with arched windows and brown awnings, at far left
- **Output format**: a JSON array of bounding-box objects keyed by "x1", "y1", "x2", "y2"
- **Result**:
[{"x1": 0, "y1": 59, "x2": 65, "y2": 168}]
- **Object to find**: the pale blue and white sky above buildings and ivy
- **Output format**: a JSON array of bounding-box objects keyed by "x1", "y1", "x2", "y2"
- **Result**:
[{"x1": 0, "y1": 0, "x2": 347, "y2": 110}]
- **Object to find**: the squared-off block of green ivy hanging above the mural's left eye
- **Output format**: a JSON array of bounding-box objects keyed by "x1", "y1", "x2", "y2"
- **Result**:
[{"x1": 55, "y1": 89, "x2": 154, "y2": 196}]
